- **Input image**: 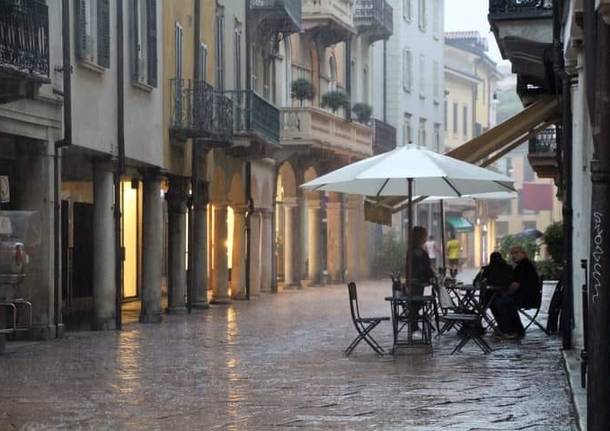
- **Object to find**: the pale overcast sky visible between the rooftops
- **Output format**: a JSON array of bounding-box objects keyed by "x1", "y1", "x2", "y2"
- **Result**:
[{"x1": 445, "y1": 0, "x2": 502, "y2": 63}]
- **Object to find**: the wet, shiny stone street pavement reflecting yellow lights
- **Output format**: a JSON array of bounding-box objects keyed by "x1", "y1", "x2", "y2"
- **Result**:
[{"x1": 0, "y1": 282, "x2": 576, "y2": 430}]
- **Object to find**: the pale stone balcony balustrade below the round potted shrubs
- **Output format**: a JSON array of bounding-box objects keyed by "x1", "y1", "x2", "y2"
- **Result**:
[{"x1": 281, "y1": 107, "x2": 373, "y2": 157}]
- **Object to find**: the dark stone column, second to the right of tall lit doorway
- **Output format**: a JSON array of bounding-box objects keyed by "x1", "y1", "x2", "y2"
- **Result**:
[{"x1": 167, "y1": 176, "x2": 188, "y2": 314}]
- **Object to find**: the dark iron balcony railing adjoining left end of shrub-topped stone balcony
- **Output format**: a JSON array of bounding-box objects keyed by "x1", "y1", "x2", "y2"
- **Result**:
[{"x1": 224, "y1": 90, "x2": 280, "y2": 145}]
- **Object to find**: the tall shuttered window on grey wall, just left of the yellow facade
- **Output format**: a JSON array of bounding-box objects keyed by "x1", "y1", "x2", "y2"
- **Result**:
[{"x1": 130, "y1": 0, "x2": 157, "y2": 87}]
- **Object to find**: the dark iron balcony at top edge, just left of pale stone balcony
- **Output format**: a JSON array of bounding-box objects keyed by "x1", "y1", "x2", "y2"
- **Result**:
[{"x1": 249, "y1": 0, "x2": 302, "y2": 33}]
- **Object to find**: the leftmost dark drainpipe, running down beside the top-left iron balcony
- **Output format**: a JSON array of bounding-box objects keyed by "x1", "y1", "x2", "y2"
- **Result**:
[{"x1": 53, "y1": 0, "x2": 72, "y2": 338}]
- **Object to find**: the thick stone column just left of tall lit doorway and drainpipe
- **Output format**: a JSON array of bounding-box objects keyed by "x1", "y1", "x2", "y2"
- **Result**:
[{"x1": 93, "y1": 161, "x2": 117, "y2": 330}]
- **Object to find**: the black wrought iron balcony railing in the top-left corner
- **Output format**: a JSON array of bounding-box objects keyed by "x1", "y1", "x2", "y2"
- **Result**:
[{"x1": 0, "y1": 0, "x2": 49, "y2": 80}]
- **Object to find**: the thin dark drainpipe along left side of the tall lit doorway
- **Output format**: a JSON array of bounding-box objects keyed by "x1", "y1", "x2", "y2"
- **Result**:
[{"x1": 114, "y1": 0, "x2": 125, "y2": 331}]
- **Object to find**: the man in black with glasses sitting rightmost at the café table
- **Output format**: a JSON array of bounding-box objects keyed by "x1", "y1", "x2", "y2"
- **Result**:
[{"x1": 491, "y1": 246, "x2": 540, "y2": 339}]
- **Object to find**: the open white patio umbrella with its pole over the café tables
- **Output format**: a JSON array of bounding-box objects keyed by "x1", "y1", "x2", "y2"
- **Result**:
[{"x1": 301, "y1": 145, "x2": 514, "y2": 290}]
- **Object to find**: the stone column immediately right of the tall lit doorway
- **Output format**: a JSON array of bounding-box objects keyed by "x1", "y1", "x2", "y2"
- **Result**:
[{"x1": 140, "y1": 171, "x2": 163, "y2": 323}]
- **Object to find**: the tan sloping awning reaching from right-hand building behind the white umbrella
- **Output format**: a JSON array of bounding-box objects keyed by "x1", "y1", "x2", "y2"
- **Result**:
[{"x1": 365, "y1": 96, "x2": 561, "y2": 224}]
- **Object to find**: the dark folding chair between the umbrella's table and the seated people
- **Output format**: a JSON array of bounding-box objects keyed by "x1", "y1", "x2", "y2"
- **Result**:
[{"x1": 433, "y1": 283, "x2": 492, "y2": 355}]
